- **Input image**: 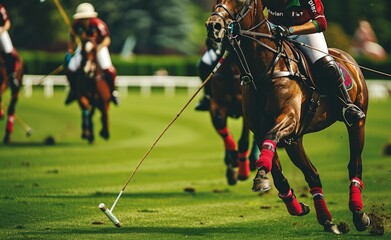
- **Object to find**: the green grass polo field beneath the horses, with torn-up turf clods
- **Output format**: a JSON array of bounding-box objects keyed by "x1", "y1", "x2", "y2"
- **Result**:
[{"x1": 0, "y1": 89, "x2": 391, "y2": 240}]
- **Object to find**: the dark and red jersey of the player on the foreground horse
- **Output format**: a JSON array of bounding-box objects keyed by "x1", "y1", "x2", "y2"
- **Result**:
[{"x1": 263, "y1": 0, "x2": 327, "y2": 32}]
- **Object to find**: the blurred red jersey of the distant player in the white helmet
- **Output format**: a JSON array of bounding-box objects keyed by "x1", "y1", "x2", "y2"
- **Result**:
[{"x1": 72, "y1": 18, "x2": 110, "y2": 44}]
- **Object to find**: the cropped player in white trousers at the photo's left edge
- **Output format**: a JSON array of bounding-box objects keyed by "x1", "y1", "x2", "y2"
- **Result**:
[{"x1": 0, "y1": 4, "x2": 20, "y2": 87}]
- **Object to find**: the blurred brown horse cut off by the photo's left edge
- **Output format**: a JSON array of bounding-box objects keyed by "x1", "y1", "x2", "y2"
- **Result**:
[{"x1": 0, "y1": 50, "x2": 24, "y2": 144}]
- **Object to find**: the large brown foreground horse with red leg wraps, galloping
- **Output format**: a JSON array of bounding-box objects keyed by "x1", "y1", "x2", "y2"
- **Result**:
[{"x1": 206, "y1": 0, "x2": 370, "y2": 234}]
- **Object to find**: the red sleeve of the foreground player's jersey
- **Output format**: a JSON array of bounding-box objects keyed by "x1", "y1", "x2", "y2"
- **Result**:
[{"x1": 300, "y1": 0, "x2": 327, "y2": 32}]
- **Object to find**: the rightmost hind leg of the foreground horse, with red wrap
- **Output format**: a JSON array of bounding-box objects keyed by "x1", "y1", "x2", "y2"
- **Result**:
[{"x1": 348, "y1": 124, "x2": 370, "y2": 231}]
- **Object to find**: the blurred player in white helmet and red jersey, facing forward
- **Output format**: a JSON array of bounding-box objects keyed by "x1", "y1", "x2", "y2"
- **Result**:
[{"x1": 65, "y1": 3, "x2": 119, "y2": 105}]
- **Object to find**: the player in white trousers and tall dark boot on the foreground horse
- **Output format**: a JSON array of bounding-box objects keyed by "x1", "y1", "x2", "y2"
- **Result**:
[{"x1": 263, "y1": 0, "x2": 365, "y2": 125}]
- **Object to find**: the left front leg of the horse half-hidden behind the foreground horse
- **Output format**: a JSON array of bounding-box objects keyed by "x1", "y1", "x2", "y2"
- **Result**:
[{"x1": 210, "y1": 104, "x2": 238, "y2": 185}]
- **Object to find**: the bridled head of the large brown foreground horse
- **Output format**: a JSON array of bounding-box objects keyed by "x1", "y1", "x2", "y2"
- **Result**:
[{"x1": 205, "y1": 0, "x2": 258, "y2": 42}]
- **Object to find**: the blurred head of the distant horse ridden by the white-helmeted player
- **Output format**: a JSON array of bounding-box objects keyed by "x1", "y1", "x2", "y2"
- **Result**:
[{"x1": 81, "y1": 39, "x2": 97, "y2": 78}]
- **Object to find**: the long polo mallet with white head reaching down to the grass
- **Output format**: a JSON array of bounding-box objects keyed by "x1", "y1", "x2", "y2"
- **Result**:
[{"x1": 99, "y1": 51, "x2": 229, "y2": 227}]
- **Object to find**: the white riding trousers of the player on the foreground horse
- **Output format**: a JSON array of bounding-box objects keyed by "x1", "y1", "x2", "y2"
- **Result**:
[{"x1": 268, "y1": 22, "x2": 329, "y2": 63}]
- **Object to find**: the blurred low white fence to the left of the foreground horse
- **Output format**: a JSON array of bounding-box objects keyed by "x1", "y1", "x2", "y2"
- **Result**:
[{"x1": 23, "y1": 75, "x2": 201, "y2": 98}]
